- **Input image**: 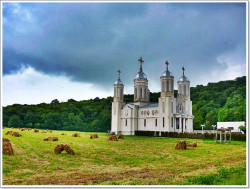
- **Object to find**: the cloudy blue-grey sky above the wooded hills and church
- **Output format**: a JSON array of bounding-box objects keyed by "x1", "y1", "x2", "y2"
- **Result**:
[{"x1": 2, "y1": 3, "x2": 246, "y2": 106}]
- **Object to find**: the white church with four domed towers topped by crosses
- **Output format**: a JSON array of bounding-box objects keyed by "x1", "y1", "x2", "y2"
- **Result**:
[{"x1": 111, "y1": 58, "x2": 194, "y2": 135}]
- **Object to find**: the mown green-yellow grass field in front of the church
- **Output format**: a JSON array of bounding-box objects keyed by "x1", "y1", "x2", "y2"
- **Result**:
[{"x1": 2, "y1": 128, "x2": 246, "y2": 185}]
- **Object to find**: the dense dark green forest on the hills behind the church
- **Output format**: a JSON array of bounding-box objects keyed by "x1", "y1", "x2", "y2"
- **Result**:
[{"x1": 2, "y1": 76, "x2": 246, "y2": 132}]
